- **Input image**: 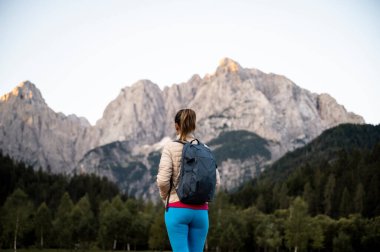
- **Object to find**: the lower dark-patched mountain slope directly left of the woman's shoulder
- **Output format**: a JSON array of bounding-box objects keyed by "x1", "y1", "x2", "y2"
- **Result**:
[{"x1": 74, "y1": 139, "x2": 168, "y2": 201}]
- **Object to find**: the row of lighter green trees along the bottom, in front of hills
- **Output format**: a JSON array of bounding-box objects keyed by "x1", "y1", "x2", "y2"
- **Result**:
[{"x1": 0, "y1": 189, "x2": 380, "y2": 252}]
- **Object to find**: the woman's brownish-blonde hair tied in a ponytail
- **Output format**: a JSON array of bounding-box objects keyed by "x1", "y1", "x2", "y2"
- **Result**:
[{"x1": 174, "y1": 109, "x2": 197, "y2": 141}]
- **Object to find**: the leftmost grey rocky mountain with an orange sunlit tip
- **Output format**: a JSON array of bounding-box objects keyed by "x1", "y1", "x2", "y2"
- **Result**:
[{"x1": 0, "y1": 81, "x2": 90, "y2": 173}]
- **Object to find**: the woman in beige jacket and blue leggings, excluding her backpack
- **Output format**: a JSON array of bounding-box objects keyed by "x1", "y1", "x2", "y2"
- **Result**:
[{"x1": 157, "y1": 109, "x2": 220, "y2": 252}]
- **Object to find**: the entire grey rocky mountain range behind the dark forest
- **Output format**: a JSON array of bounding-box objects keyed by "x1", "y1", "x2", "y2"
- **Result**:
[{"x1": 0, "y1": 58, "x2": 364, "y2": 199}]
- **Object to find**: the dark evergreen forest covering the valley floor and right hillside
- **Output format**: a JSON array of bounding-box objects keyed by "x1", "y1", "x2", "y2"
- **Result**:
[{"x1": 0, "y1": 124, "x2": 380, "y2": 252}]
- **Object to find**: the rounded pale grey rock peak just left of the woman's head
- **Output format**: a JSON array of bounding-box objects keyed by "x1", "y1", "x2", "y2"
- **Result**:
[{"x1": 95, "y1": 80, "x2": 166, "y2": 146}]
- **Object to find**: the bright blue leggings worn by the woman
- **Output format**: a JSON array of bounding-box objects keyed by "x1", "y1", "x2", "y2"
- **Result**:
[{"x1": 165, "y1": 207, "x2": 208, "y2": 252}]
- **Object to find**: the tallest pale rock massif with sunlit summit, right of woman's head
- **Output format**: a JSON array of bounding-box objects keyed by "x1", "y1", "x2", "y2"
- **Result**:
[{"x1": 170, "y1": 59, "x2": 364, "y2": 157}]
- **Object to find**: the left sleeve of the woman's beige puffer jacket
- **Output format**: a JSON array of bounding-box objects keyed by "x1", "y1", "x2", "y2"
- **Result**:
[{"x1": 157, "y1": 146, "x2": 173, "y2": 201}]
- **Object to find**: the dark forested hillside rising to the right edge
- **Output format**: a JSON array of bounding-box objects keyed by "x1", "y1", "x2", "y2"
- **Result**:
[{"x1": 231, "y1": 124, "x2": 380, "y2": 217}]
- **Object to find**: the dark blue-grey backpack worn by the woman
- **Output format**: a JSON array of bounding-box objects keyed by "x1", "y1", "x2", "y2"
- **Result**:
[{"x1": 166, "y1": 139, "x2": 217, "y2": 210}]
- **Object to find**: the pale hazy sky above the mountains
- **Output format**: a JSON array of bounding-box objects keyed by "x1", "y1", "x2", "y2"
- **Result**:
[{"x1": 0, "y1": 0, "x2": 380, "y2": 124}]
